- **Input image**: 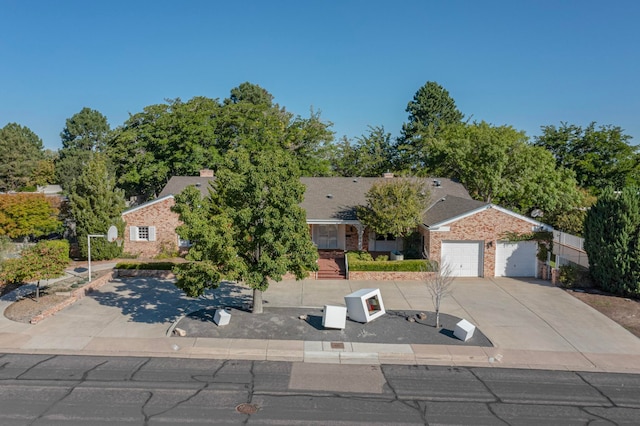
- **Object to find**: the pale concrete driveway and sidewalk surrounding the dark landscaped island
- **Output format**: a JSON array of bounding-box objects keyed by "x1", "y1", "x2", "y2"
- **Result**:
[{"x1": 0, "y1": 272, "x2": 640, "y2": 374}]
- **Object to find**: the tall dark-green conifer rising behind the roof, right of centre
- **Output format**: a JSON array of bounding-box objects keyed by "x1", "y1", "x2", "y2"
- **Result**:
[{"x1": 397, "y1": 81, "x2": 464, "y2": 174}]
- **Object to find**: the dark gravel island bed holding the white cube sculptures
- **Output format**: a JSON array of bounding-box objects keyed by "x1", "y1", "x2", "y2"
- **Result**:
[{"x1": 172, "y1": 308, "x2": 493, "y2": 347}]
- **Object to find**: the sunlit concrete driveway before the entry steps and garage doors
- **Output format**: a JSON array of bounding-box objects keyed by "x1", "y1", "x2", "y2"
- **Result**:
[{"x1": 265, "y1": 278, "x2": 640, "y2": 354}]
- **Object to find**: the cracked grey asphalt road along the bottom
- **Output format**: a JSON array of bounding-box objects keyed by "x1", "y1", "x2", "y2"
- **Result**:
[{"x1": 0, "y1": 354, "x2": 640, "y2": 426}]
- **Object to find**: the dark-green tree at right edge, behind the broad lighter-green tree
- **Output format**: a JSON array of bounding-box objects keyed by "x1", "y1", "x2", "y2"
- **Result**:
[{"x1": 534, "y1": 122, "x2": 640, "y2": 195}]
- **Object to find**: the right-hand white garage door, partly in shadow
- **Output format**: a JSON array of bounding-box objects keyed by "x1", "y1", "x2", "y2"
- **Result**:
[{"x1": 496, "y1": 241, "x2": 538, "y2": 277}]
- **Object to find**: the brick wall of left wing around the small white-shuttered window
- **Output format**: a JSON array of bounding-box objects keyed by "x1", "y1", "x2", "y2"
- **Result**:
[{"x1": 123, "y1": 197, "x2": 181, "y2": 258}]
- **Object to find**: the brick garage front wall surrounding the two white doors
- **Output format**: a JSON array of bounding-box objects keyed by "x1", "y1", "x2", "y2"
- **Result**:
[{"x1": 425, "y1": 208, "x2": 533, "y2": 277}]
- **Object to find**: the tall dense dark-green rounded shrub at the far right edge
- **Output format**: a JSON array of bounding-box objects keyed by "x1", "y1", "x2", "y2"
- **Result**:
[{"x1": 584, "y1": 187, "x2": 640, "y2": 296}]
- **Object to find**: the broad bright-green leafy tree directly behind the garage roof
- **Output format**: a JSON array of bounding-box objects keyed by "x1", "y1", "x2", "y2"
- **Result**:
[{"x1": 428, "y1": 122, "x2": 581, "y2": 218}]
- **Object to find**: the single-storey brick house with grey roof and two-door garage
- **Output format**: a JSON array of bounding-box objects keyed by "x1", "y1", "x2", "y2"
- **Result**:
[{"x1": 123, "y1": 171, "x2": 551, "y2": 277}]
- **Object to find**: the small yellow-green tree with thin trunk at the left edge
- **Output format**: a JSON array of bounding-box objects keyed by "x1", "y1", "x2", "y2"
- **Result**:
[{"x1": 0, "y1": 240, "x2": 69, "y2": 300}]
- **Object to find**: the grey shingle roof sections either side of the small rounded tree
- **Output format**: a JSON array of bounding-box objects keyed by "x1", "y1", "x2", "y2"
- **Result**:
[{"x1": 300, "y1": 177, "x2": 471, "y2": 223}]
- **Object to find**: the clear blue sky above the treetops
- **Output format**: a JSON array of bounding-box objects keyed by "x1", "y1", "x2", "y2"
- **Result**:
[{"x1": 0, "y1": 0, "x2": 640, "y2": 149}]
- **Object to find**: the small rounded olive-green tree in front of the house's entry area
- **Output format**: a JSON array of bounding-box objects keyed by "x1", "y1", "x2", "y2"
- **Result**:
[{"x1": 357, "y1": 178, "x2": 429, "y2": 251}]
